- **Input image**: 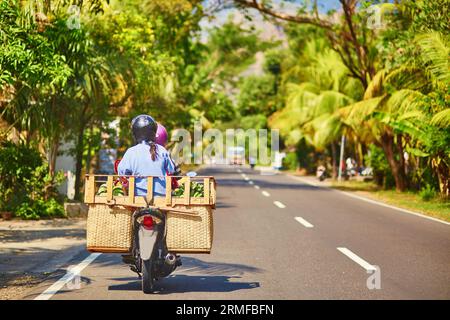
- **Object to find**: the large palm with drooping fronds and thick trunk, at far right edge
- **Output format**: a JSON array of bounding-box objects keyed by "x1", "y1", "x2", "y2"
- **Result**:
[{"x1": 339, "y1": 32, "x2": 450, "y2": 193}]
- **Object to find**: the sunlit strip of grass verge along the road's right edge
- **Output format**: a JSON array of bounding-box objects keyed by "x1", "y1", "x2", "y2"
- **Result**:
[{"x1": 331, "y1": 180, "x2": 450, "y2": 222}]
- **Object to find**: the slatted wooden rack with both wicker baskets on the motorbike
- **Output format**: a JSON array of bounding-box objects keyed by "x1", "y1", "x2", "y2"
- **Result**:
[{"x1": 85, "y1": 175, "x2": 216, "y2": 253}]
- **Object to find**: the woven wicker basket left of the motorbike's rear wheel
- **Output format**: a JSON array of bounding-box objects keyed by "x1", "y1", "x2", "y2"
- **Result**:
[{"x1": 87, "y1": 204, "x2": 133, "y2": 253}]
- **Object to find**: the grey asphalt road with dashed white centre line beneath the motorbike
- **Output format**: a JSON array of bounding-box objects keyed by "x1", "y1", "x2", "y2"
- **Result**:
[{"x1": 25, "y1": 167, "x2": 450, "y2": 300}]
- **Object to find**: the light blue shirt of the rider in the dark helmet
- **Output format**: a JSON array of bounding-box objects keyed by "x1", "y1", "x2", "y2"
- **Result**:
[{"x1": 117, "y1": 142, "x2": 175, "y2": 196}]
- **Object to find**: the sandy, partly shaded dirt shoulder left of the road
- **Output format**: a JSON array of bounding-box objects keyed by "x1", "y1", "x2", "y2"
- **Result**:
[{"x1": 0, "y1": 218, "x2": 86, "y2": 300}]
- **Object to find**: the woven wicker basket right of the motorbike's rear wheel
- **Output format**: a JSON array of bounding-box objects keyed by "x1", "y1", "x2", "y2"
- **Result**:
[{"x1": 166, "y1": 205, "x2": 213, "y2": 253}]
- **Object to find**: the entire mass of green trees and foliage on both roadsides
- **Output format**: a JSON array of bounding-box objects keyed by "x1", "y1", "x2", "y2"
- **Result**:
[{"x1": 0, "y1": 0, "x2": 450, "y2": 218}]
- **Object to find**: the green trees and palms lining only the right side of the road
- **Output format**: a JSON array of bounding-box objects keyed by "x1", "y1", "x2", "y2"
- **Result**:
[{"x1": 255, "y1": 1, "x2": 450, "y2": 195}]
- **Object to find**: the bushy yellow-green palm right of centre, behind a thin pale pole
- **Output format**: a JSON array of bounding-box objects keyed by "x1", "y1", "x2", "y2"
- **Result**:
[{"x1": 270, "y1": 47, "x2": 362, "y2": 176}]
